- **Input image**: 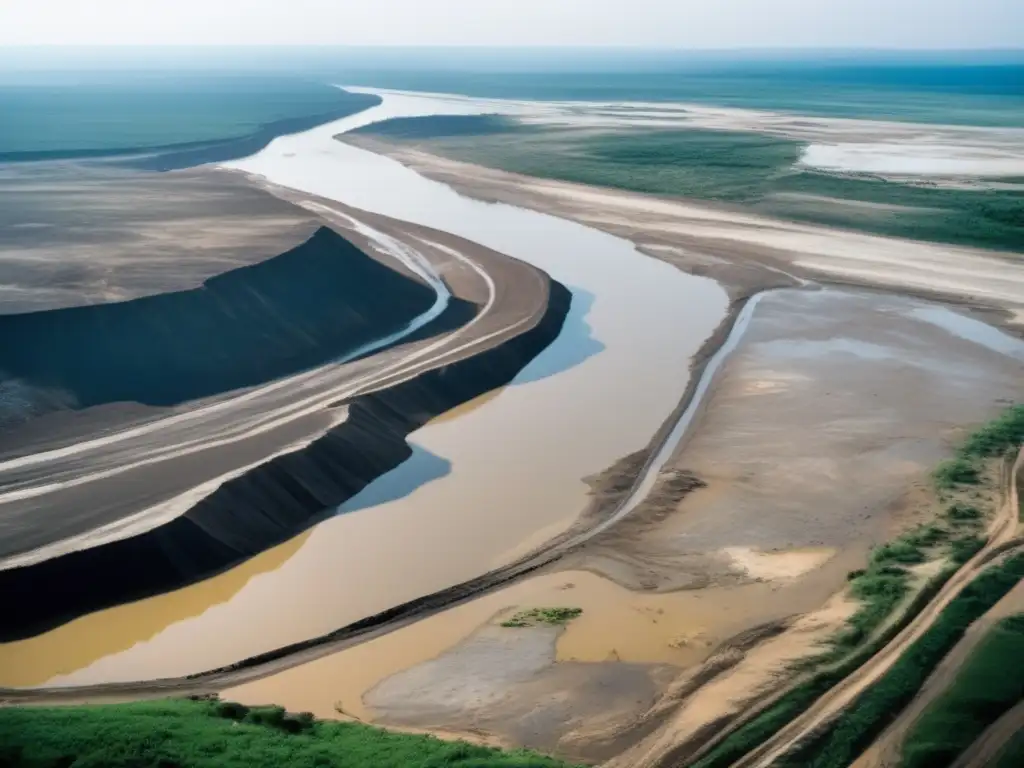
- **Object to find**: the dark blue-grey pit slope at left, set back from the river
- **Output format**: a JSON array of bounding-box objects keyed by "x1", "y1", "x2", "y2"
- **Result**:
[{"x1": 0, "y1": 227, "x2": 456, "y2": 408}]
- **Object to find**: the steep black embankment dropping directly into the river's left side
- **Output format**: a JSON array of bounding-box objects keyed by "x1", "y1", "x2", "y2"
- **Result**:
[{"x1": 0, "y1": 281, "x2": 571, "y2": 641}]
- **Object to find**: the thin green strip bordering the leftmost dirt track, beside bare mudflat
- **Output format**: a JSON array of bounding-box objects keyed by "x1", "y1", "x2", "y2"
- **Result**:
[{"x1": 694, "y1": 567, "x2": 956, "y2": 768}]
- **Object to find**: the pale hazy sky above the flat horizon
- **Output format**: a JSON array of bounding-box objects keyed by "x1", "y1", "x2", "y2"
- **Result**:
[{"x1": 0, "y1": 0, "x2": 1024, "y2": 48}]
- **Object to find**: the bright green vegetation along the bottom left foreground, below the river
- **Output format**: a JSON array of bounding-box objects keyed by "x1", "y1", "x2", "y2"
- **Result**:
[{"x1": 0, "y1": 699, "x2": 567, "y2": 768}]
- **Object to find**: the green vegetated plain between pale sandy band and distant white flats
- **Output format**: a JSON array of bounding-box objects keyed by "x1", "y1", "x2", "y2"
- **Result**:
[{"x1": 362, "y1": 116, "x2": 1024, "y2": 251}]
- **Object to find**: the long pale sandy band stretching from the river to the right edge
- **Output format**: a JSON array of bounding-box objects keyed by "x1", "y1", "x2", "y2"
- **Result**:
[{"x1": 345, "y1": 136, "x2": 1024, "y2": 327}]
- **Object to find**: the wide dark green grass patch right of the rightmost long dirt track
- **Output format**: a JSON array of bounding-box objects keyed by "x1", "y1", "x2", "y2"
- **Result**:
[{"x1": 900, "y1": 615, "x2": 1024, "y2": 768}]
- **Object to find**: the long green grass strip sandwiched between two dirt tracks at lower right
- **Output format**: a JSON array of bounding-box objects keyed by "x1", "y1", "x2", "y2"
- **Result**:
[{"x1": 779, "y1": 555, "x2": 1024, "y2": 768}]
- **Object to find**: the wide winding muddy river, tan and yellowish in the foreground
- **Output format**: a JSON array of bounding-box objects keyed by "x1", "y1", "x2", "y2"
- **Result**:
[{"x1": 0, "y1": 94, "x2": 727, "y2": 687}]
